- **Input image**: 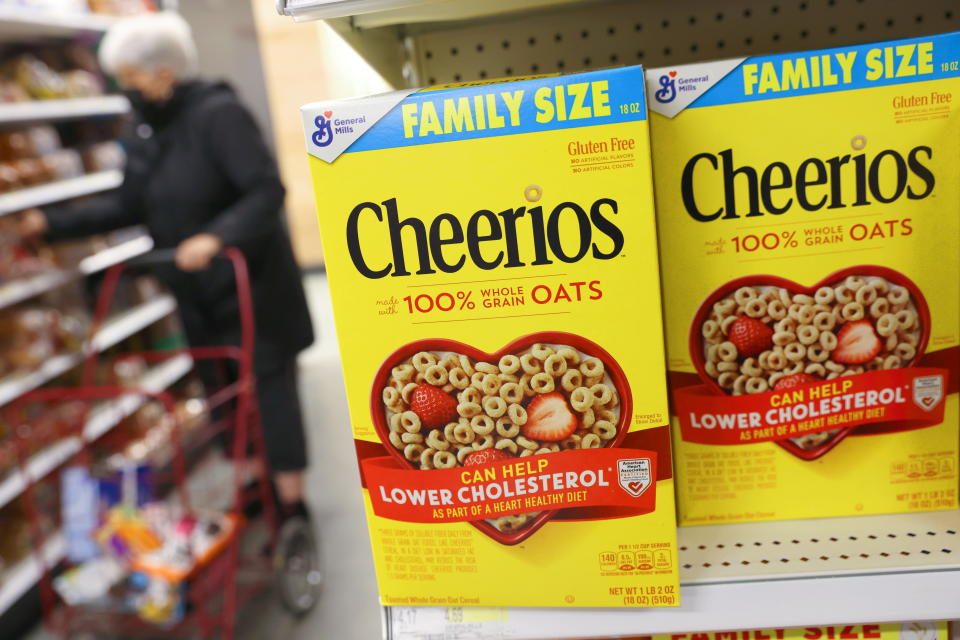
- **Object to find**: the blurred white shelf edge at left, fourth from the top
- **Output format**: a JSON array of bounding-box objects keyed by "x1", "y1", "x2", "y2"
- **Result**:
[{"x1": 0, "y1": 295, "x2": 177, "y2": 406}]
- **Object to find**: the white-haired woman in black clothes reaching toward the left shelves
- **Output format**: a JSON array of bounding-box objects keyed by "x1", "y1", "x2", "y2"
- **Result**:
[{"x1": 21, "y1": 14, "x2": 313, "y2": 515}]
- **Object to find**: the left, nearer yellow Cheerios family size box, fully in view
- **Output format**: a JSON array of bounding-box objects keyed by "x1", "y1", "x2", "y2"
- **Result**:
[{"x1": 303, "y1": 67, "x2": 678, "y2": 607}]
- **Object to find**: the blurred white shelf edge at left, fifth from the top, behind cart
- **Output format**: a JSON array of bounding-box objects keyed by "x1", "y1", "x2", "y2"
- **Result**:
[{"x1": 0, "y1": 355, "x2": 193, "y2": 510}]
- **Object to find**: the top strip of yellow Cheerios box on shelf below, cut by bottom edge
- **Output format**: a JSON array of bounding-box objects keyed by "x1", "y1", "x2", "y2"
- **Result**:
[{"x1": 636, "y1": 622, "x2": 950, "y2": 640}]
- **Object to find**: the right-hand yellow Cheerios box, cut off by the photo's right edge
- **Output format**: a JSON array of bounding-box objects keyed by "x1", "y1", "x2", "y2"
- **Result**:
[{"x1": 647, "y1": 34, "x2": 960, "y2": 525}]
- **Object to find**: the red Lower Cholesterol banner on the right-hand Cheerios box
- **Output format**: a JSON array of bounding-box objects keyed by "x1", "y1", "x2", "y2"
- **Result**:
[{"x1": 674, "y1": 367, "x2": 948, "y2": 445}]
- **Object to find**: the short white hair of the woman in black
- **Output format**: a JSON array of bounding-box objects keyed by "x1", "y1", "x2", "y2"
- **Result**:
[{"x1": 98, "y1": 11, "x2": 197, "y2": 80}]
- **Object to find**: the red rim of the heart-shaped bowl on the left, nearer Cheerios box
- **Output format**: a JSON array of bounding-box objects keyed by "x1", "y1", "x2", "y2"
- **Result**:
[{"x1": 370, "y1": 331, "x2": 633, "y2": 545}]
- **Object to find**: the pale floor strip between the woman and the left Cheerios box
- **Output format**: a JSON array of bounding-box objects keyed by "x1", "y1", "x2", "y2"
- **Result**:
[{"x1": 23, "y1": 275, "x2": 381, "y2": 640}]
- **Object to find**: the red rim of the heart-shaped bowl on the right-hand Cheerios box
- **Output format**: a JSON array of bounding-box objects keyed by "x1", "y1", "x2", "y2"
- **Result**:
[{"x1": 689, "y1": 265, "x2": 930, "y2": 460}]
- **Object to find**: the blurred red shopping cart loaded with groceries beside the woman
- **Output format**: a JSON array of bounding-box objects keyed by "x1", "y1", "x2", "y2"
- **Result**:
[{"x1": 7, "y1": 248, "x2": 322, "y2": 640}]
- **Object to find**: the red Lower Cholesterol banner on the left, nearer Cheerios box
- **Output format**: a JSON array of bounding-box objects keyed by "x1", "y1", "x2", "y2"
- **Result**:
[{"x1": 361, "y1": 448, "x2": 657, "y2": 522}]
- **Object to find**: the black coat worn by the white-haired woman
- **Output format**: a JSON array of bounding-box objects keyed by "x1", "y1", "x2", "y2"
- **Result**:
[{"x1": 45, "y1": 82, "x2": 313, "y2": 360}]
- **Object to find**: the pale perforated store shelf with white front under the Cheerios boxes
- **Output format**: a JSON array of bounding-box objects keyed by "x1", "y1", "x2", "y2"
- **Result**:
[{"x1": 385, "y1": 511, "x2": 960, "y2": 640}]
